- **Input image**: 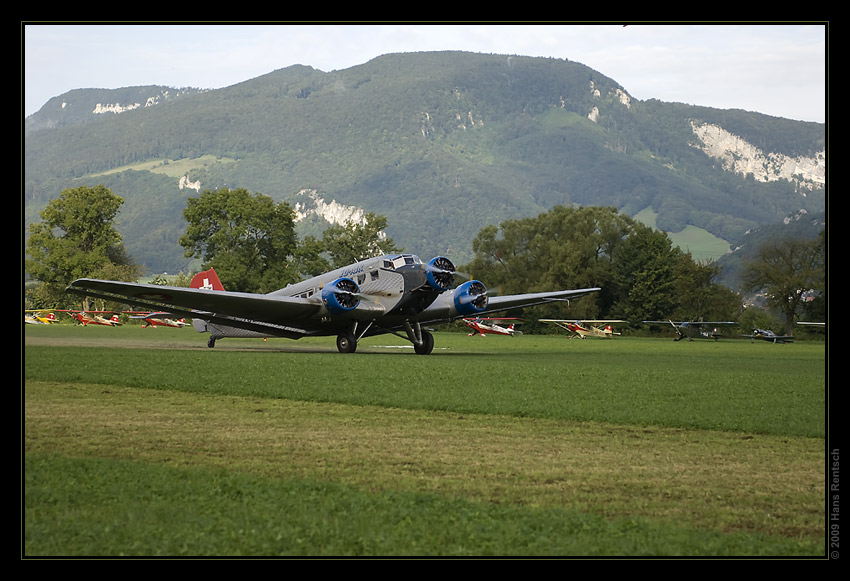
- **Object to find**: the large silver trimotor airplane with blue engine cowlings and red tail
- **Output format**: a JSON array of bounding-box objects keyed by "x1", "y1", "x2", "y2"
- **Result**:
[{"x1": 67, "y1": 254, "x2": 599, "y2": 354}]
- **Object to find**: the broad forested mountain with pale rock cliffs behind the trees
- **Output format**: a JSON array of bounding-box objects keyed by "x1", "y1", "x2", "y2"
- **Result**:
[{"x1": 24, "y1": 52, "x2": 826, "y2": 272}]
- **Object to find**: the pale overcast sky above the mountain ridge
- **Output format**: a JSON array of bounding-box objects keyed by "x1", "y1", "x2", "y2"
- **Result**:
[{"x1": 22, "y1": 23, "x2": 827, "y2": 122}]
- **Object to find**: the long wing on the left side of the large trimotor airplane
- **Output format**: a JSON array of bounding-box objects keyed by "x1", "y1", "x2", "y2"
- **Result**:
[{"x1": 67, "y1": 278, "x2": 321, "y2": 339}]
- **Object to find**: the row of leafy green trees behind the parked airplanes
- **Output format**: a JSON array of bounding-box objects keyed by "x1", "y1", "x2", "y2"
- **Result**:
[{"x1": 25, "y1": 186, "x2": 826, "y2": 331}]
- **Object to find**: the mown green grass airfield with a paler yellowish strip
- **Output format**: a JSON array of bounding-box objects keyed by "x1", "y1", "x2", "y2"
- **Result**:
[{"x1": 22, "y1": 325, "x2": 827, "y2": 558}]
